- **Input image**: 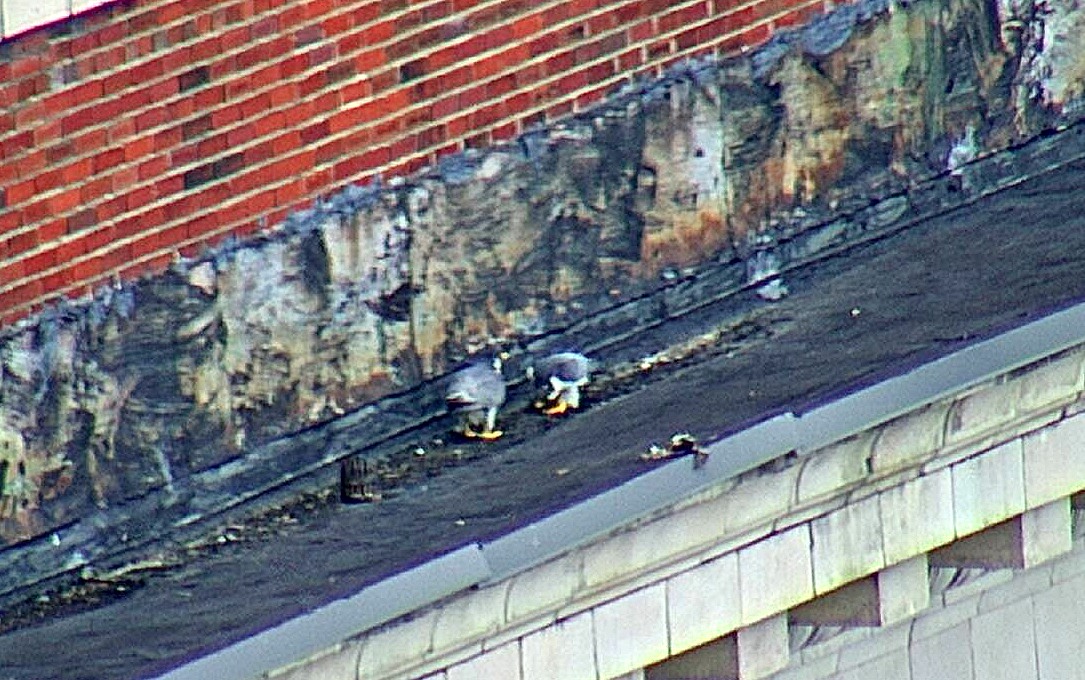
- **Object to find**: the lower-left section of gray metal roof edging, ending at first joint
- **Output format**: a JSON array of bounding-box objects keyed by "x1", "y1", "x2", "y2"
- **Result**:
[{"x1": 159, "y1": 546, "x2": 489, "y2": 680}]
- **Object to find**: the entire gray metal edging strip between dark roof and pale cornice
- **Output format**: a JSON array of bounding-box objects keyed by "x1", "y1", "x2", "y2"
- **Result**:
[{"x1": 161, "y1": 304, "x2": 1085, "y2": 680}]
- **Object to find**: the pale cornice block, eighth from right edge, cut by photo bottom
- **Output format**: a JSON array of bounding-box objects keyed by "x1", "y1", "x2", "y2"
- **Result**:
[{"x1": 520, "y1": 612, "x2": 597, "y2": 680}]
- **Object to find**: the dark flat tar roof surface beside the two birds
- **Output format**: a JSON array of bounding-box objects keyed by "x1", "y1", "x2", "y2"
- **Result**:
[{"x1": 6, "y1": 150, "x2": 1085, "y2": 679}]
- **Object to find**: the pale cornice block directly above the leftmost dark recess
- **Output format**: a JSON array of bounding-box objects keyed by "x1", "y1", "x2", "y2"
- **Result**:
[{"x1": 666, "y1": 552, "x2": 741, "y2": 654}]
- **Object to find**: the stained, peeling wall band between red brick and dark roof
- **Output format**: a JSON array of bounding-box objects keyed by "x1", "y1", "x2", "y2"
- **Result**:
[{"x1": 0, "y1": 0, "x2": 1085, "y2": 590}]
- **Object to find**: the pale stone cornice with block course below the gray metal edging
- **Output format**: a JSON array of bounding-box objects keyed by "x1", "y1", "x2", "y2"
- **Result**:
[{"x1": 264, "y1": 314, "x2": 1085, "y2": 680}]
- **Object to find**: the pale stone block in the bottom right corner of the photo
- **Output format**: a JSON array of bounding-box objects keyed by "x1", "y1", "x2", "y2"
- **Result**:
[{"x1": 1033, "y1": 576, "x2": 1085, "y2": 680}]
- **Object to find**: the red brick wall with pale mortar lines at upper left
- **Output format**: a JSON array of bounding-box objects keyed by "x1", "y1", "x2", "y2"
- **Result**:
[{"x1": 0, "y1": 0, "x2": 831, "y2": 322}]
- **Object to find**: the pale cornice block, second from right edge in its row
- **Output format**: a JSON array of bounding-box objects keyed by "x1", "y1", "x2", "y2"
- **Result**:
[{"x1": 950, "y1": 439, "x2": 1024, "y2": 537}]
